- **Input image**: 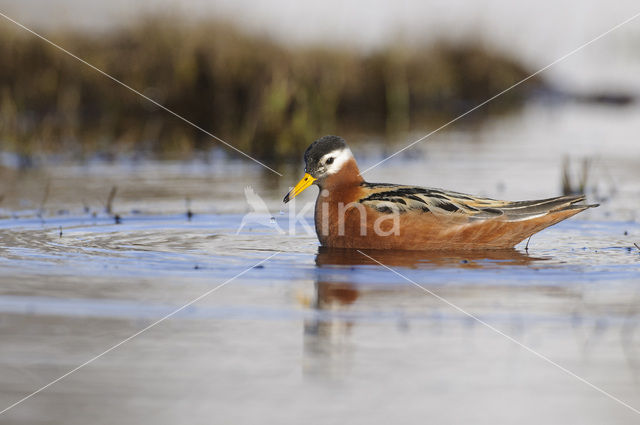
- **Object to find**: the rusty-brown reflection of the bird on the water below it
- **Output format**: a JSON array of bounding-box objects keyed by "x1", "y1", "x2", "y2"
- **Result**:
[{"x1": 304, "y1": 247, "x2": 545, "y2": 377}]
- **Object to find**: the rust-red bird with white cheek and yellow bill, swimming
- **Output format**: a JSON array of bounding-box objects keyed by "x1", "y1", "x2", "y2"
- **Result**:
[{"x1": 283, "y1": 136, "x2": 598, "y2": 251}]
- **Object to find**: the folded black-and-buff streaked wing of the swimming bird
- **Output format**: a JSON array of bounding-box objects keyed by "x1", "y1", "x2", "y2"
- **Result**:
[{"x1": 358, "y1": 183, "x2": 584, "y2": 221}]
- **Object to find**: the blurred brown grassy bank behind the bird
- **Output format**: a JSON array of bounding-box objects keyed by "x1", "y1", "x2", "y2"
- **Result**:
[{"x1": 0, "y1": 16, "x2": 542, "y2": 163}]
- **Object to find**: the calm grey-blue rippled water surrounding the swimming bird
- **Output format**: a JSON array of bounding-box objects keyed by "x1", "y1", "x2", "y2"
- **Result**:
[{"x1": 0, "y1": 101, "x2": 640, "y2": 424}]
